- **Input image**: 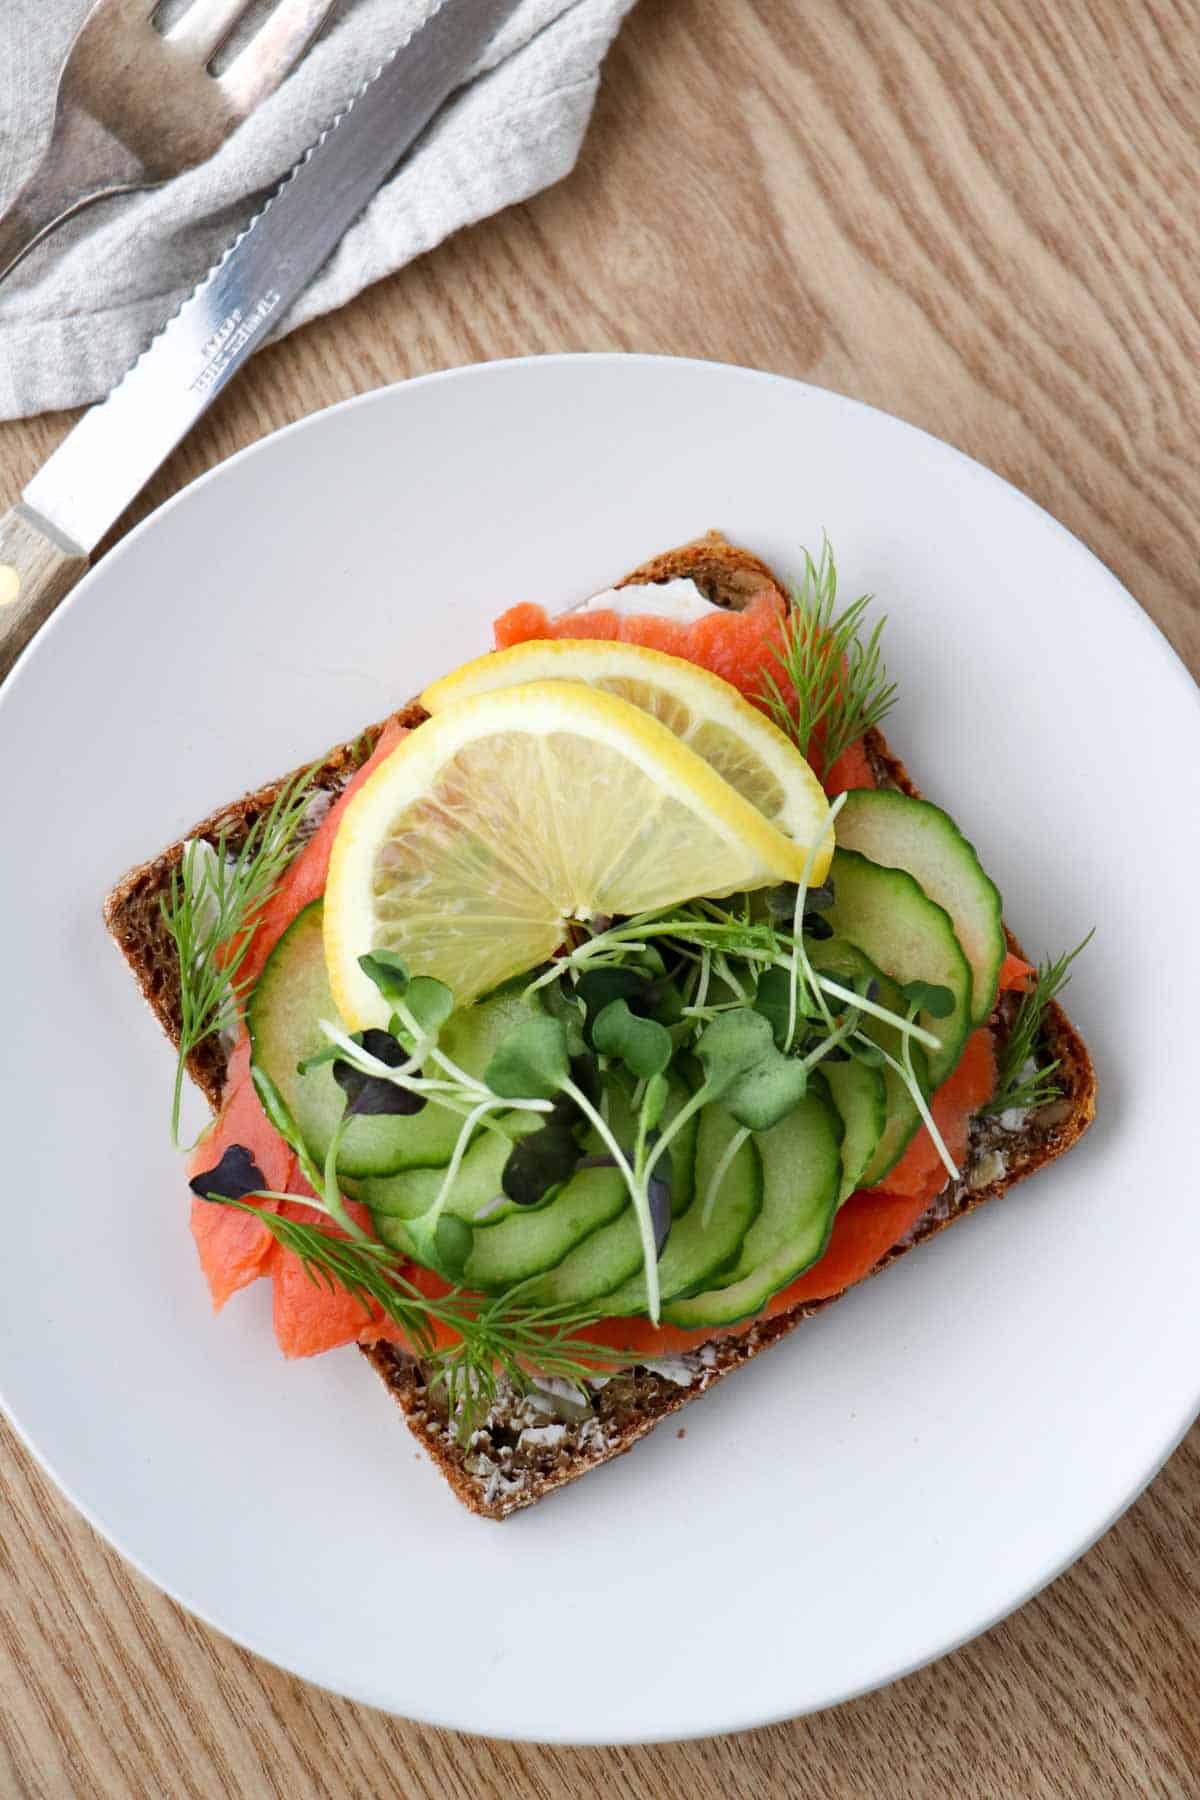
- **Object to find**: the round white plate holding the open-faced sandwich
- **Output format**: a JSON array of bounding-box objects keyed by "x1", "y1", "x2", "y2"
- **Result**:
[{"x1": 0, "y1": 356, "x2": 1200, "y2": 1742}]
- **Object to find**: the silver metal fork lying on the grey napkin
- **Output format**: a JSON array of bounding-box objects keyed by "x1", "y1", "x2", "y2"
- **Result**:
[{"x1": 0, "y1": 0, "x2": 335, "y2": 281}]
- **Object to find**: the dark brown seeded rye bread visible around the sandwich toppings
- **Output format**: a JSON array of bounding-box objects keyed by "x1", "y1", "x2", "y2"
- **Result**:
[{"x1": 104, "y1": 531, "x2": 1096, "y2": 1519}]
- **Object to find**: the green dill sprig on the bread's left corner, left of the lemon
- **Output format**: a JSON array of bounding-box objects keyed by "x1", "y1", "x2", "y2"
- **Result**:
[{"x1": 158, "y1": 770, "x2": 311, "y2": 1145}]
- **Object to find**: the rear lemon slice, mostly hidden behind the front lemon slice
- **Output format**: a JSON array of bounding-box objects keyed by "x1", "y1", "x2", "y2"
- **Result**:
[{"x1": 421, "y1": 637, "x2": 831, "y2": 856}]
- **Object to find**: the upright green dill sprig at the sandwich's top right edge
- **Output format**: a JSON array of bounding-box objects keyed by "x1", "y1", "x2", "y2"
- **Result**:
[{"x1": 759, "y1": 538, "x2": 896, "y2": 770}]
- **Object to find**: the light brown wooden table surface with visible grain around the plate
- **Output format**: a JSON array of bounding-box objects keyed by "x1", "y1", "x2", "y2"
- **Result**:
[{"x1": 0, "y1": 0, "x2": 1200, "y2": 1800}]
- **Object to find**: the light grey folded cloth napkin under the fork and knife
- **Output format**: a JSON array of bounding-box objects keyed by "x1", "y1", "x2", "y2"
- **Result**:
[{"x1": 0, "y1": 0, "x2": 633, "y2": 418}]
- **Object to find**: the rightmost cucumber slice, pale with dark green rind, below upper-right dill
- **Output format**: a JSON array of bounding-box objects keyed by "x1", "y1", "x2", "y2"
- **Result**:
[{"x1": 837, "y1": 788, "x2": 1007, "y2": 1024}]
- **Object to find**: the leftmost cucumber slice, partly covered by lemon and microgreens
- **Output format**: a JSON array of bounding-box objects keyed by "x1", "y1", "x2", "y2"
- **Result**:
[{"x1": 246, "y1": 900, "x2": 529, "y2": 1177}]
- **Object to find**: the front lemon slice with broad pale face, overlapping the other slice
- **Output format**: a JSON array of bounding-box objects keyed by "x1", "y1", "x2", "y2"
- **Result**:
[{"x1": 324, "y1": 682, "x2": 806, "y2": 1030}]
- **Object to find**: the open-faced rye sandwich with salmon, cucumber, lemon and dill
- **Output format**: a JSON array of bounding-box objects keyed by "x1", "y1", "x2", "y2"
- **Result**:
[{"x1": 106, "y1": 535, "x2": 1094, "y2": 1517}]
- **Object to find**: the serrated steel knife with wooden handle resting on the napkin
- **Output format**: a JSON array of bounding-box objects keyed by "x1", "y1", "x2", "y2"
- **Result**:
[{"x1": 0, "y1": 0, "x2": 522, "y2": 679}]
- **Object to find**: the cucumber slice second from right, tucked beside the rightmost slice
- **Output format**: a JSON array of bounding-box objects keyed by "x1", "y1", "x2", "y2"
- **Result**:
[{"x1": 826, "y1": 848, "x2": 972, "y2": 1087}]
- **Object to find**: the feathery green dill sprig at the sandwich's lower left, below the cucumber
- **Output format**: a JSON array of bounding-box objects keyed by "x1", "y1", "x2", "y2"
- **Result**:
[{"x1": 209, "y1": 1193, "x2": 637, "y2": 1444}]
